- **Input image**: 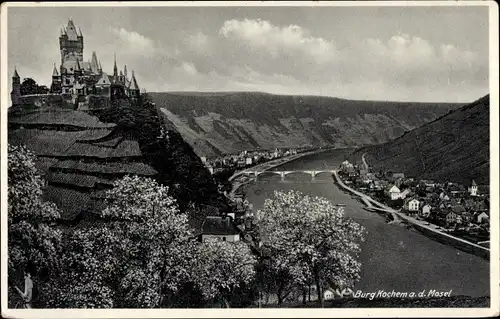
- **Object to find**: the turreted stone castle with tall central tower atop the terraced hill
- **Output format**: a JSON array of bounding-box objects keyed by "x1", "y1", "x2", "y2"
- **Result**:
[{"x1": 11, "y1": 18, "x2": 141, "y2": 109}]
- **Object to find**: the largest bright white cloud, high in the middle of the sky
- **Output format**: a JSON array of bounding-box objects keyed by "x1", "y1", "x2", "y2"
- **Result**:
[{"x1": 219, "y1": 19, "x2": 335, "y2": 63}]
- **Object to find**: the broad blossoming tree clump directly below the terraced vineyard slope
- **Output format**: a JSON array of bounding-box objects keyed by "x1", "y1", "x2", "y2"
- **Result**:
[{"x1": 44, "y1": 176, "x2": 194, "y2": 308}]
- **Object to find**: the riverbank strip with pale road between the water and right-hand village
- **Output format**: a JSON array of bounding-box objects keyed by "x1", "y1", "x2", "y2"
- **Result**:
[{"x1": 334, "y1": 172, "x2": 490, "y2": 260}]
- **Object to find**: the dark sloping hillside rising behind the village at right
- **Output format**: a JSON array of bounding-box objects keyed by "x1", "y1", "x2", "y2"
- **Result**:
[{"x1": 353, "y1": 95, "x2": 490, "y2": 185}]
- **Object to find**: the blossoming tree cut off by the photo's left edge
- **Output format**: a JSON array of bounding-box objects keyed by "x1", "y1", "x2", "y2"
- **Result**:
[{"x1": 7, "y1": 145, "x2": 62, "y2": 304}]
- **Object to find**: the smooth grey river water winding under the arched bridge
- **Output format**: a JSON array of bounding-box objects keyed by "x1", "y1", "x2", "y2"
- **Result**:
[{"x1": 242, "y1": 150, "x2": 490, "y2": 297}]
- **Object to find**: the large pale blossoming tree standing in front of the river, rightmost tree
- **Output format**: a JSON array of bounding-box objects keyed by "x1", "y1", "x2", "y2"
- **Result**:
[{"x1": 256, "y1": 191, "x2": 364, "y2": 307}]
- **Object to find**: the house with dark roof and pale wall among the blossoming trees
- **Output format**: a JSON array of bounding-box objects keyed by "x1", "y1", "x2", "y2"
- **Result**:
[{"x1": 201, "y1": 215, "x2": 241, "y2": 242}]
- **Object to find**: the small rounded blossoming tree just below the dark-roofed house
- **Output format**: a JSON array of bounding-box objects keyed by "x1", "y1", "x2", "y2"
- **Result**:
[{"x1": 193, "y1": 241, "x2": 256, "y2": 308}]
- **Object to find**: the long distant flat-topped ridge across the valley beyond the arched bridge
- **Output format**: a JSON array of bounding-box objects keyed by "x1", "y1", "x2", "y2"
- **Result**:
[{"x1": 149, "y1": 92, "x2": 461, "y2": 156}]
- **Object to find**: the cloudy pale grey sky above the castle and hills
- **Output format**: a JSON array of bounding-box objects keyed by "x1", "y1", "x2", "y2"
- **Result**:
[{"x1": 8, "y1": 6, "x2": 489, "y2": 102}]
